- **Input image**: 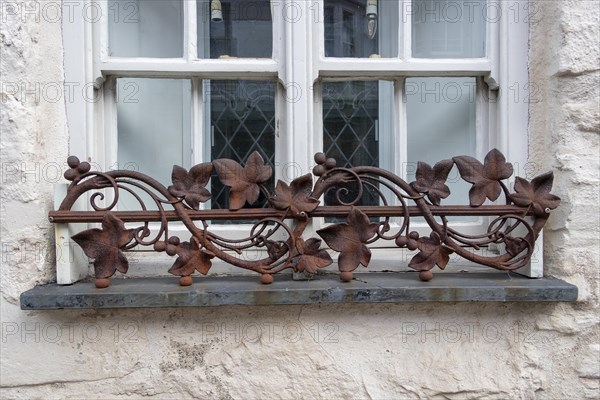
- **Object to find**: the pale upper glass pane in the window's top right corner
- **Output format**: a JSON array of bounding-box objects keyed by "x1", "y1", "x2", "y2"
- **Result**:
[{"x1": 411, "y1": 0, "x2": 486, "y2": 58}]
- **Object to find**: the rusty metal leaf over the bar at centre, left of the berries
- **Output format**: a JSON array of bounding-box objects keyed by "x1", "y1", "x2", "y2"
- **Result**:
[{"x1": 269, "y1": 174, "x2": 319, "y2": 218}]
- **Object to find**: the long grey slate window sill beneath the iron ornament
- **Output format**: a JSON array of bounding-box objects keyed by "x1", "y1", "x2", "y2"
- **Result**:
[{"x1": 21, "y1": 272, "x2": 577, "y2": 310}]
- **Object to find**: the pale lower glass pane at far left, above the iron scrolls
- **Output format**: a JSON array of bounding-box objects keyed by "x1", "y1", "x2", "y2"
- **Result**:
[{"x1": 116, "y1": 78, "x2": 191, "y2": 209}]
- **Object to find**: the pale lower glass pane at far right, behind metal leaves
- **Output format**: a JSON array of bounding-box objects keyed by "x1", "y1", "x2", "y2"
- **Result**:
[{"x1": 405, "y1": 77, "x2": 477, "y2": 209}]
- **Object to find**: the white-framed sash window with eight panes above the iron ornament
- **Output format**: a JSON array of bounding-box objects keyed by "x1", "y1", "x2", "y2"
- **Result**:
[{"x1": 59, "y1": 0, "x2": 528, "y2": 282}]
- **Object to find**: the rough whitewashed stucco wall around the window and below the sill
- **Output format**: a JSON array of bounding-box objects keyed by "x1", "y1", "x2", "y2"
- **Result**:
[{"x1": 0, "y1": 1, "x2": 600, "y2": 399}]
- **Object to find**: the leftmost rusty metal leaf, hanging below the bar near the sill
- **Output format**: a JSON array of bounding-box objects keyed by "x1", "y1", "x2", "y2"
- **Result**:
[{"x1": 72, "y1": 212, "x2": 135, "y2": 279}]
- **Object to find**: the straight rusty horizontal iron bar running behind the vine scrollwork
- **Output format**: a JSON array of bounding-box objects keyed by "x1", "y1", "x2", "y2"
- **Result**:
[{"x1": 48, "y1": 205, "x2": 531, "y2": 223}]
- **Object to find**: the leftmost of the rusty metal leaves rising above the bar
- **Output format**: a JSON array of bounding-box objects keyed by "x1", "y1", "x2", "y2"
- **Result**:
[{"x1": 169, "y1": 163, "x2": 212, "y2": 210}]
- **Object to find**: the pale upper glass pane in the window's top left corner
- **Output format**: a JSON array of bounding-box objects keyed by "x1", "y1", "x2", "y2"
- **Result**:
[{"x1": 108, "y1": 0, "x2": 183, "y2": 58}]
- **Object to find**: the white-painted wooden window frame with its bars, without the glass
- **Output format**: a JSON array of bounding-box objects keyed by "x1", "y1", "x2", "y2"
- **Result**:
[{"x1": 59, "y1": 0, "x2": 543, "y2": 283}]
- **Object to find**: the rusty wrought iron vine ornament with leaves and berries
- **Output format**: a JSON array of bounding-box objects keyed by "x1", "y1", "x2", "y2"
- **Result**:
[{"x1": 49, "y1": 149, "x2": 560, "y2": 288}]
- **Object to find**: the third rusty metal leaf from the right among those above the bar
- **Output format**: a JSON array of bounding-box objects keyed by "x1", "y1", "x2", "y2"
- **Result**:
[{"x1": 410, "y1": 160, "x2": 454, "y2": 206}]
